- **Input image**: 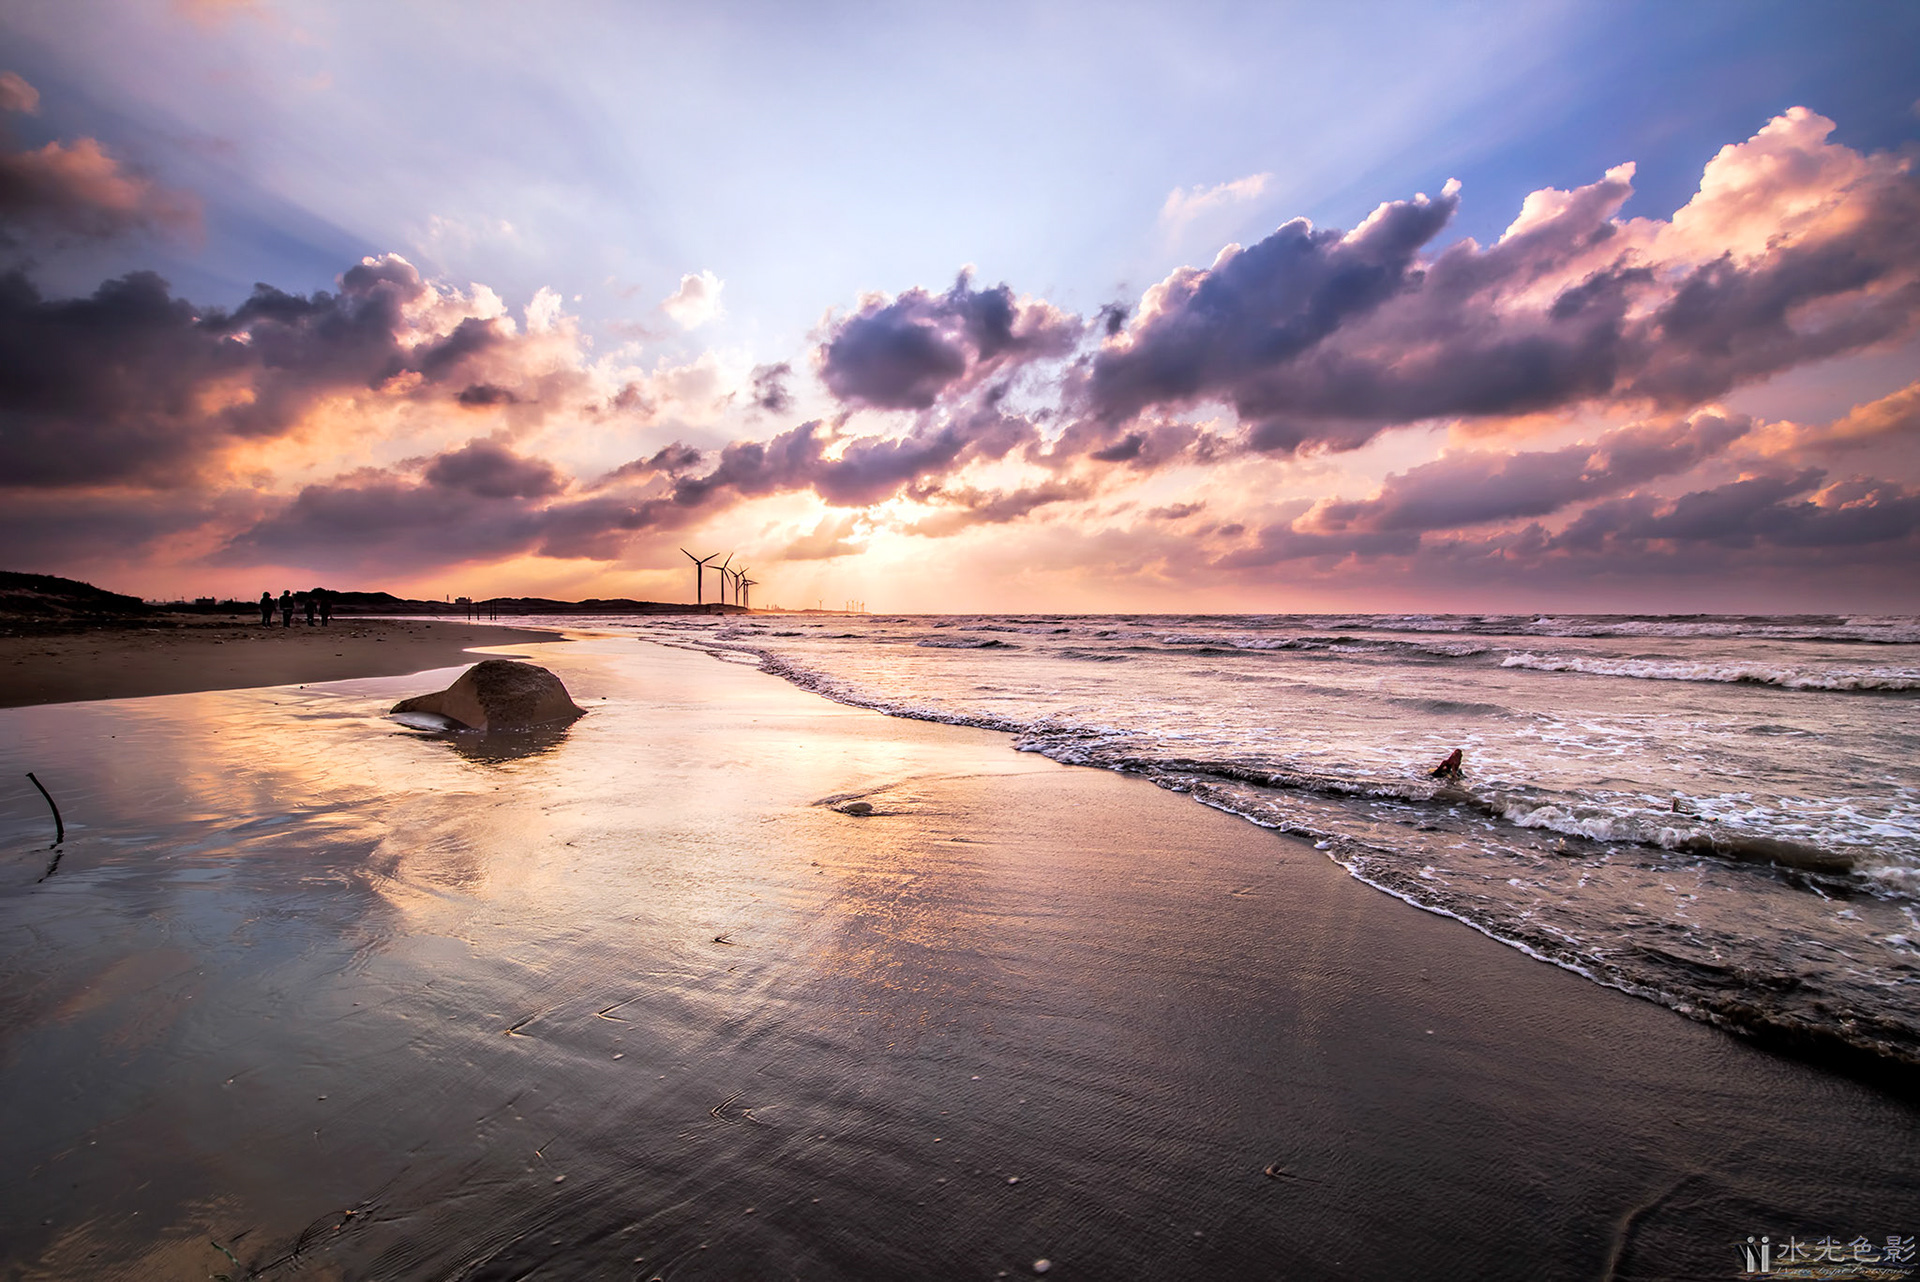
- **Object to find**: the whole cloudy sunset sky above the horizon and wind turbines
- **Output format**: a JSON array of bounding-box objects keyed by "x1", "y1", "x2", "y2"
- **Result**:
[{"x1": 0, "y1": 0, "x2": 1920, "y2": 614}]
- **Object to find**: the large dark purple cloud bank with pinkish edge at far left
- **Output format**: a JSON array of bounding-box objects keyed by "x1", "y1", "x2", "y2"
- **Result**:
[{"x1": 0, "y1": 255, "x2": 578, "y2": 487}]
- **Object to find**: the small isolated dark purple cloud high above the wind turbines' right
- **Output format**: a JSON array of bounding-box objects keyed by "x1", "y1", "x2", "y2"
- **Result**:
[{"x1": 816, "y1": 273, "x2": 1083, "y2": 409}]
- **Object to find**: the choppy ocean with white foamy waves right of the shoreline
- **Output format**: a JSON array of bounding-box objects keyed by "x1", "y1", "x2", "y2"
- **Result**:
[{"x1": 602, "y1": 614, "x2": 1920, "y2": 1065}]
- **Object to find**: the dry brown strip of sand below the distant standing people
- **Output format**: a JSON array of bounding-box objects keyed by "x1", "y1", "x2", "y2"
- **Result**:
[{"x1": 0, "y1": 618, "x2": 553, "y2": 708}]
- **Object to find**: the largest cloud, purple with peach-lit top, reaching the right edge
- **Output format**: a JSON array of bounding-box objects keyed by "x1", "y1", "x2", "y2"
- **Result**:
[{"x1": 1077, "y1": 107, "x2": 1920, "y2": 453}]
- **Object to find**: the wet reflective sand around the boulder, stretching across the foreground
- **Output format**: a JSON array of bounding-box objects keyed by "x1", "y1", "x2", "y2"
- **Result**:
[{"x1": 0, "y1": 639, "x2": 1920, "y2": 1282}]
